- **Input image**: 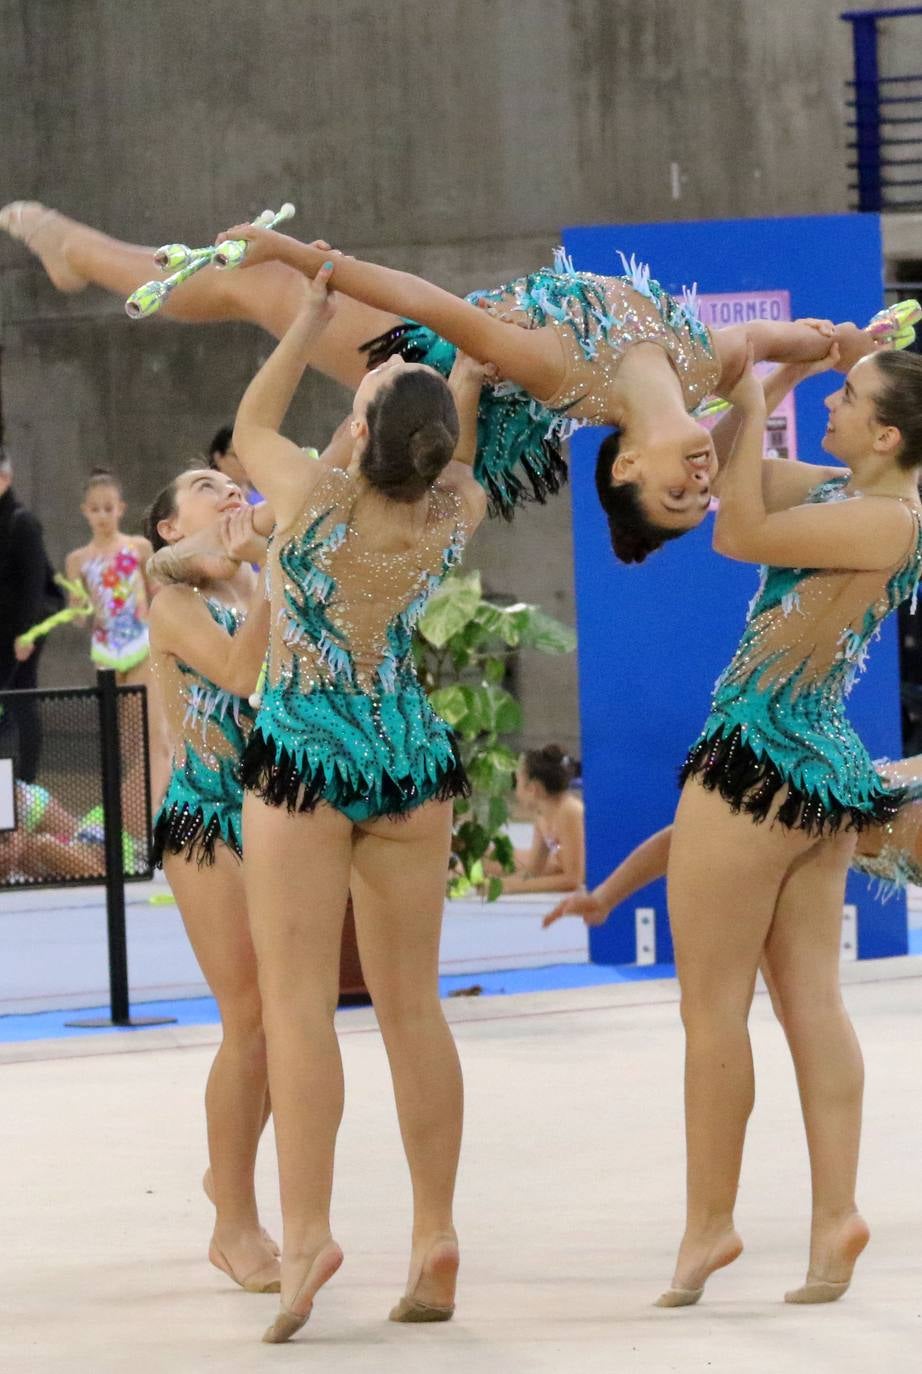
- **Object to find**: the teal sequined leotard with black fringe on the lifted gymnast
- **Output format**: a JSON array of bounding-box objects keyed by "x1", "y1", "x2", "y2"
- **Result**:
[{"x1": 364, "y1": 250, "x2": 720, "y2": 518}]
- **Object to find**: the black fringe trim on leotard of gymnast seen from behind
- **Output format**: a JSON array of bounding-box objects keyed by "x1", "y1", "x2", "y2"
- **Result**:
[{"x1": 240, "y1": 730, "x2": 470, "y2": 816}]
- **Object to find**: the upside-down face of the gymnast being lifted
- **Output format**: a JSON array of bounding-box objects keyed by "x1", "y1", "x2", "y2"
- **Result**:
[{"x1": 611, "y1": 418, "x2": 717, "y2": 533}]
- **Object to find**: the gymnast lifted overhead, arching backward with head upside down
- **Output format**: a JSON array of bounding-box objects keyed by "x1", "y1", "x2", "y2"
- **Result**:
[{"x1": 0, "y1": 201, "x2": 899, "y2": 562}]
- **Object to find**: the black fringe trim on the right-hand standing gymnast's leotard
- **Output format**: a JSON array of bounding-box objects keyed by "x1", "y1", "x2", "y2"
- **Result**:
[{"x1": 679, "y1": 725, "x2": 903, "y2": 837}]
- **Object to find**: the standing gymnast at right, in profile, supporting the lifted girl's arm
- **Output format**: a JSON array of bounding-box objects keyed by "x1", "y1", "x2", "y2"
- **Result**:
[{"x1": 648, "y1": 353, "x2": 922, "y2": 1305}]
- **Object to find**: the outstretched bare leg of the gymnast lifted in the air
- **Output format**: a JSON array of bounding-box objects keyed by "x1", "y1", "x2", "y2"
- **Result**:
[{"x1": 0, "y1": 202, "x2": 400, "y2": 390}]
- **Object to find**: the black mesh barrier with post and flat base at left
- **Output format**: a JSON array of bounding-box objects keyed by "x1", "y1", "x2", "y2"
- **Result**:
[{"x1": 0, "y1": 669, "x2": 173, "y2": 1026}]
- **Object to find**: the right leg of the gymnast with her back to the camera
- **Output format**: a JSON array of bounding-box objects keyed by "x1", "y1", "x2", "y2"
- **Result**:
[{"x1": 352, "y1": 802, "x2": 463, "y2": 1320}]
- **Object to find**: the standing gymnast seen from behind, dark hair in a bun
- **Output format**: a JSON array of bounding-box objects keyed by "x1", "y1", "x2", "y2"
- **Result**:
[{"x1": 189, "y1": 259, "x2": 485, "y2": 1342}]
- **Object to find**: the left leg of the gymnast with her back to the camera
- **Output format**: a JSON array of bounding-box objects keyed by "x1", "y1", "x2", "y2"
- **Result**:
[{"x1": 243, "y1": 793, "x2": 352, "y2": 1338}]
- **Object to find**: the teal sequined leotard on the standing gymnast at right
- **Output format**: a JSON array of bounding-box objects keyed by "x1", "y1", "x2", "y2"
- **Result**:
[{"x1": 682, "y1": 473, "x2": 922, "y2": 834}]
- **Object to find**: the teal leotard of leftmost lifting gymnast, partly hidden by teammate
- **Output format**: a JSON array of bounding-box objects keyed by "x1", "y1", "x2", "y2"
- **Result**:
[{"x1": 154, "y1": 596, "x2": 254, "y2": 864}]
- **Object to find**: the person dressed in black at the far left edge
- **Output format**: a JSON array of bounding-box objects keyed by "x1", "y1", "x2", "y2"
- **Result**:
[{"x1": 0, "y1": 449, "x2": 63, "y2": 783}]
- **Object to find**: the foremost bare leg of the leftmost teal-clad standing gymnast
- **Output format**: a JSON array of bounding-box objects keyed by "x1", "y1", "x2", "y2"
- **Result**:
[{"x1": 164, "y1": 845, "x2": 279, "y2": 1292}]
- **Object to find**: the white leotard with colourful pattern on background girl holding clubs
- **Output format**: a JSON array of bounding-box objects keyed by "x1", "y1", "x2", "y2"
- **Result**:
[{"x1": 80, "y1": 544, "x2": 150, "y2": 673}]
